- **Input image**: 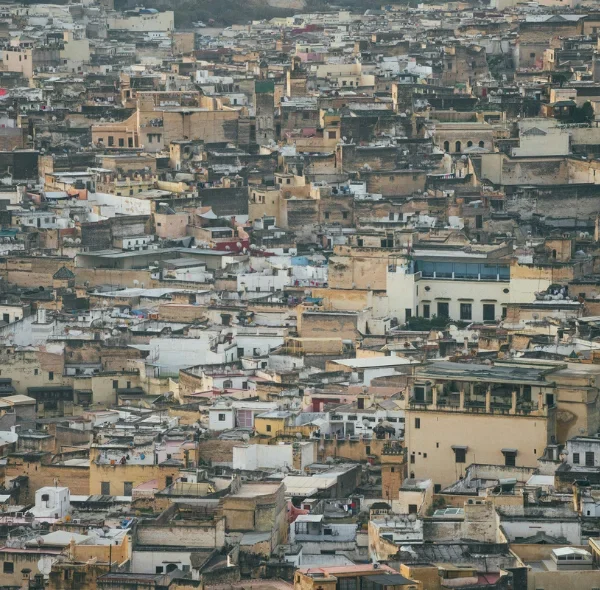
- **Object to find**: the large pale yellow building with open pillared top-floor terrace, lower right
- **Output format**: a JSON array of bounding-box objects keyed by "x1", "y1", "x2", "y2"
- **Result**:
[{"x1": 405, "y1": 362, "x2": 556, "y2": 491}]
